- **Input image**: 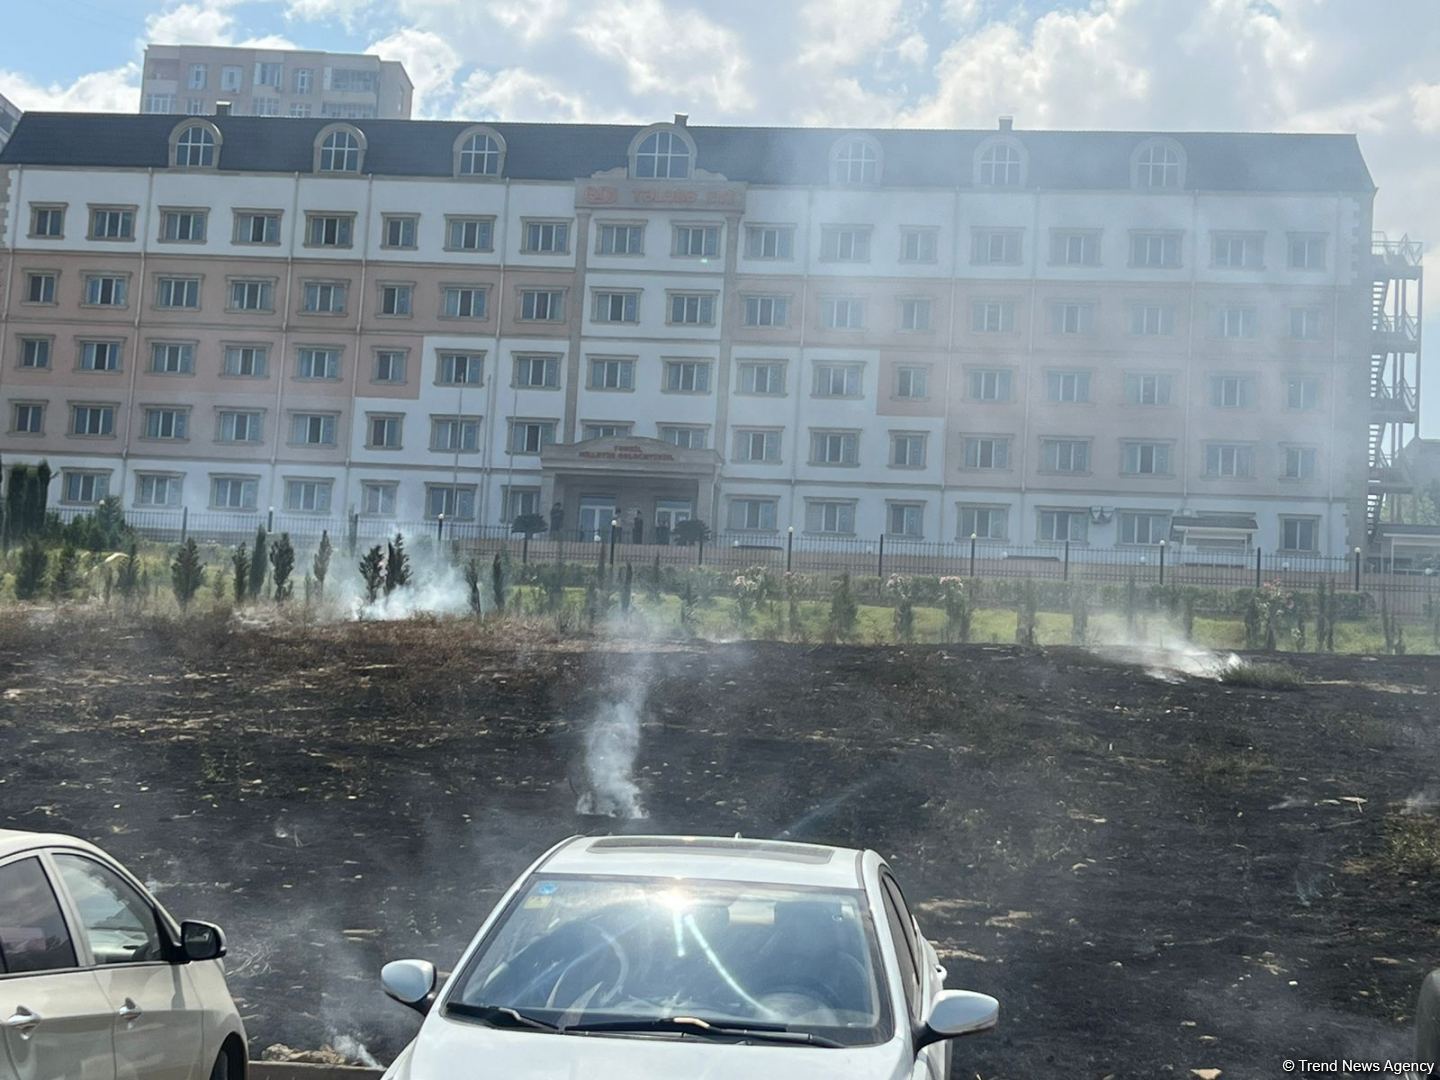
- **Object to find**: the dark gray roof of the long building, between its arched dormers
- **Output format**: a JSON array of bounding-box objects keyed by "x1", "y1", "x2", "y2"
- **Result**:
[{"x1": 0, "y1": 112, "x2": 1375, "y2": 193}]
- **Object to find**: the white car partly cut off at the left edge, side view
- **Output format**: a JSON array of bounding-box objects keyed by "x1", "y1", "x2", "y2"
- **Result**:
[{"x1": 0, "y1": 829, "x2": 246, "y2": 1080}]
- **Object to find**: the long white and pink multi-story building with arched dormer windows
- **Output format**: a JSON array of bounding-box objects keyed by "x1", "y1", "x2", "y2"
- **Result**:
[{"x1": 0, "y1": 114, "x2": 1418, "y2": 554}]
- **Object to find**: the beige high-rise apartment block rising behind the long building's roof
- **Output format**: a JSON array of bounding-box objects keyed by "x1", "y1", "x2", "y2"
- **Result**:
[{"x1": 140, "y1": 45, "x2": 413, "y2": 120}]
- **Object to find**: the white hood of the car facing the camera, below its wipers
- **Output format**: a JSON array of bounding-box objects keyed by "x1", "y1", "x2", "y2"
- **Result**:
[{"x1": 386, "y1": 1017, "x2": 914, "y2": 1080}]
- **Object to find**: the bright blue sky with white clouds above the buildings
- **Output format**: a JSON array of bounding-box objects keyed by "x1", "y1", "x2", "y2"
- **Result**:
[{"x1": 0, "y1": 0, "x2": 1440, "y2": 438}]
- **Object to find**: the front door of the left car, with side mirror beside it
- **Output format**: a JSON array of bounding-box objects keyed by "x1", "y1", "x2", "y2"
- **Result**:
[{"x1": 50, "y1": 851, "x2": 207, "y2": 1080}]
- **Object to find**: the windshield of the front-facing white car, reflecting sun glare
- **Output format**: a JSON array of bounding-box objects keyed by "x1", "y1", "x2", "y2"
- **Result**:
[{"x1": 446, "y1": 876, "x2": 888, "y2": 1045}]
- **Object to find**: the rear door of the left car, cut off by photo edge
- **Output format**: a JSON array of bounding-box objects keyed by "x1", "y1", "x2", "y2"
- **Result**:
[{"x1": 0, "y1": 854, "x2": 115, "y2": 1080}]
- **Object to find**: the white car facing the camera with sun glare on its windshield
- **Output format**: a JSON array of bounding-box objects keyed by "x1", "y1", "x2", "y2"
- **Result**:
[{"x1": 380, "y1": 837, "x2": 999, "y2": 1080}]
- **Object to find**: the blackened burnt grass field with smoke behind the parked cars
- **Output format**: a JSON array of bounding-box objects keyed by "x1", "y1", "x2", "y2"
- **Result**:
[{"x1": 0, "y1": 615, "x2": 1440, "y2": 1080}]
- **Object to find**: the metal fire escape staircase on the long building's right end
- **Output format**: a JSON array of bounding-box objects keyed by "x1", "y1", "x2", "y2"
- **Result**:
[{"x1": 1365, "y1": 233, "x2": 1424, "y2": 536}]
